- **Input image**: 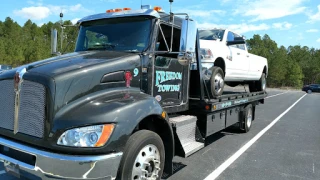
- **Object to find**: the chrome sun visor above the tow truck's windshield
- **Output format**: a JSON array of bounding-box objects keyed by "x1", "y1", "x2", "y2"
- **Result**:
[{"x1": 77, "y1": 9, "x2": 160, "y2": 23}]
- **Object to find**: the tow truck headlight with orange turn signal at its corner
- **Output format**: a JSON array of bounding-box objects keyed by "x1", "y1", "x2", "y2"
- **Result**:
[{"x1": 57, "y1": 124, "x2": 114, "y2": 147}]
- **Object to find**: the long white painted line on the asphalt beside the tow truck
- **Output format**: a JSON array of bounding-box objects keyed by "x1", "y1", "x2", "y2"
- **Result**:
[{"x1": 205, "y1": 94, "x2": 307, "y2": 180}]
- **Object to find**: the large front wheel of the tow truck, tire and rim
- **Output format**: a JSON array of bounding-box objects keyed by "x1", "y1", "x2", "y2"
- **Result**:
[{"x1": 117, "y1": 130, "x2": 165, "y2": 180}]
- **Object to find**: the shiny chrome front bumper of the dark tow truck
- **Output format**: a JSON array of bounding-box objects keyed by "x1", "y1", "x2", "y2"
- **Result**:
[{"x1": 0, "y1": 137, "x2": 123, "y2": 179}]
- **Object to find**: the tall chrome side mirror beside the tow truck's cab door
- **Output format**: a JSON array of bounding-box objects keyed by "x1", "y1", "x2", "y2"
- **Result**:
[{"x1": 178, "y1": 18, "x2": 197, "y2": 65}]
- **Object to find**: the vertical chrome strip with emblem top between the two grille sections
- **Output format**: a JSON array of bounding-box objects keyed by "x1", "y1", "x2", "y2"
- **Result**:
[{"x1": 13, "y1": 68, "x2": 27, "y2": 134}]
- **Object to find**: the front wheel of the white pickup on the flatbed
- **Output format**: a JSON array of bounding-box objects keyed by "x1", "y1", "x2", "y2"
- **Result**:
[{"x1": 210, "y1": 66, "x2": 224, "y2": 97}]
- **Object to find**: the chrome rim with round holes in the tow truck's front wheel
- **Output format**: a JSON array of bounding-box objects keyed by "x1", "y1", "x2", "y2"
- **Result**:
[{"x1": 132, "y1": 144, "x2": 160, "y2": 180}]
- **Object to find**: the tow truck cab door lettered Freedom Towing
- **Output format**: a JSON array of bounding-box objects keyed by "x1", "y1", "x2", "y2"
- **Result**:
[{"x1": 153, "y1": 24, "x2": 189, "y2": 106}]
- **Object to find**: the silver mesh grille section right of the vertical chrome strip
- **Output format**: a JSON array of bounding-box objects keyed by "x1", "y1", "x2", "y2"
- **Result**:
[{"x1": 18, "y1": 80, "x2": 46, "y2": 138}]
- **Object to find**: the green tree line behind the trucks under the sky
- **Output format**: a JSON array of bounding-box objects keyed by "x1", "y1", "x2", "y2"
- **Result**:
[{"x1": 0, "y1": 17, "x2": 320, "y2": 88}]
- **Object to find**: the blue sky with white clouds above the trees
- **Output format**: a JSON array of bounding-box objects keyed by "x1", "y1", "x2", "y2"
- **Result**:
[{"x1": 0, "y1": 0, "x2": 320, "y2": 49}]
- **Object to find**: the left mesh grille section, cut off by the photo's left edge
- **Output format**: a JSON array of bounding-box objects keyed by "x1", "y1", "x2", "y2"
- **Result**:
[{"x1": 0, "y1": 80, "x2": 15, "y2": 130}]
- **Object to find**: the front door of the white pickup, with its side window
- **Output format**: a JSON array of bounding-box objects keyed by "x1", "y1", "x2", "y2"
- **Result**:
[{"x1": 227, "y1": 31, "x2": 250, "y2": 81}]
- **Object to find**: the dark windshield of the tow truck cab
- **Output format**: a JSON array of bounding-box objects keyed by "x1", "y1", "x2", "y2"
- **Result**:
[{"x1": 75, "y1": 17, "x2": 151, "y2": 52}]
